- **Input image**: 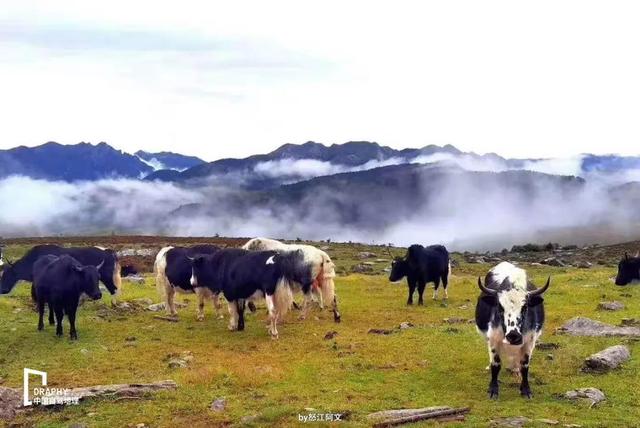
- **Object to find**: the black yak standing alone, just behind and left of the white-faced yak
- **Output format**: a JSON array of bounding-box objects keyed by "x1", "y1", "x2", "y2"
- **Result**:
[{"x1": 389, "y1": 244, "x2": 451, "y2": 305}]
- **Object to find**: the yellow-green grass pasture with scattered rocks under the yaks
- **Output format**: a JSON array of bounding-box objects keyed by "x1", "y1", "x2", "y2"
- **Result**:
[{"x1": 0, "y1": 239, "x2": 640, "y2": 427}]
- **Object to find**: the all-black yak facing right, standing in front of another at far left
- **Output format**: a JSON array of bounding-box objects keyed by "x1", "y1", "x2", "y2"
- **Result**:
[{"x1": 33, "y1": 255, "x2": 103, "y2": 340}]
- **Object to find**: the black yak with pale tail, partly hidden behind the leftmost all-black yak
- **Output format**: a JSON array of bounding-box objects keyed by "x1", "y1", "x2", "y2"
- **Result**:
[{"x1": 0, "y1": 245, "x2": 122, "y2": 302}]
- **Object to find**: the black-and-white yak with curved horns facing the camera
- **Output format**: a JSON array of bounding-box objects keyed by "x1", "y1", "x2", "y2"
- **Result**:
[{"x1": 476, "y1": 262, "x2": 551, "y2": 398}]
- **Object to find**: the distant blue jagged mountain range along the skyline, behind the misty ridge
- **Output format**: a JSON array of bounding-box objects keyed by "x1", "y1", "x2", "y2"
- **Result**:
[{"x1": 5, "y1": 141, "x2": 640, "y2": 190}]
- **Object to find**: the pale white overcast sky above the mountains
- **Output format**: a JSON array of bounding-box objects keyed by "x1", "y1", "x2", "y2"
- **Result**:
[{"x1": 0, "y1": 0, "x2": 640, "y2": 160}]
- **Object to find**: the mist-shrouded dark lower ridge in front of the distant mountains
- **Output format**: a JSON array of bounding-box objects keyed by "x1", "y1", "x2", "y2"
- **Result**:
[{"x1": 0, "y1": 160, "x2": 640, "y2": 250}]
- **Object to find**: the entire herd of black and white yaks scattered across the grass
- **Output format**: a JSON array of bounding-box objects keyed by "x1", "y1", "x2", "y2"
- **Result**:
[{"x1": 0, "y1": 238, "x2": 640, "y2": 398}]
